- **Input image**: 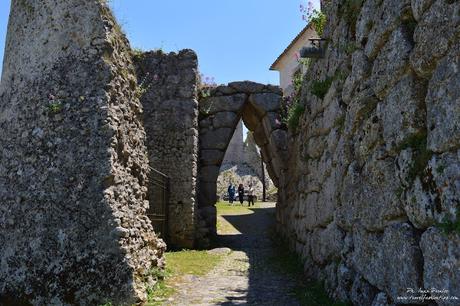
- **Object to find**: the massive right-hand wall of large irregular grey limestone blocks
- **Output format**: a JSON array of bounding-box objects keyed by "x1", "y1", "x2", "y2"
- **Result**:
[{"x1": 277, "y1": 0, "x2": 460, "y2": 305}]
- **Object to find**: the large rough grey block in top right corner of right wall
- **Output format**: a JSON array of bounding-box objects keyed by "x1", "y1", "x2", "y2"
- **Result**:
[{"x1": 410, "y1": 1, "x2": 460, "y2": 77}]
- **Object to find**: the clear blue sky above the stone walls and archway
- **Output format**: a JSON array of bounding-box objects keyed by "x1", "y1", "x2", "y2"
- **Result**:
[{"x1": 0, "y1": 0, "x2": 319, "y2": 84}]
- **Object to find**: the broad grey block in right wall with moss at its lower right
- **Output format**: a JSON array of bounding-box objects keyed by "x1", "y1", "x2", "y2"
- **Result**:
[{"x1": 377, "y1": 75, "x2": 426, "y2": 151}]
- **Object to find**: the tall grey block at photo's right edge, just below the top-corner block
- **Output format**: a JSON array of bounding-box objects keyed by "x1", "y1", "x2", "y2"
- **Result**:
[{"x1": 426, "y1": 42, "x2": 460, "y2": 152}]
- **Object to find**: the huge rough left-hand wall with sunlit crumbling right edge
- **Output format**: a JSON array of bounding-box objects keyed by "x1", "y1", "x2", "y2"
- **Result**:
[{"x1": 0, "y1": 0, "x2": 164, "y2": 305}]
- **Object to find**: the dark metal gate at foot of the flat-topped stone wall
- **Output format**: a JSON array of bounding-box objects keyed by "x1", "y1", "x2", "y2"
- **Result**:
[{"x1": 147, "y1": 168, "x2": 170, "y2": 240}]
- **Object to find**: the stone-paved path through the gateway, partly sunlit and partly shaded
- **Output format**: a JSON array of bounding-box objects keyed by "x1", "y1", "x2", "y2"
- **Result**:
[{"x1": 166, "y1": 203, "x2": 300, "y2": 305}]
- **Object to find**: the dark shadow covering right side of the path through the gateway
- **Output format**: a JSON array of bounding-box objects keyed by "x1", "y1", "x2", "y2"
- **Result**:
[{"x1": 217, "y1": 203, "x2": 300, "y2": 305}]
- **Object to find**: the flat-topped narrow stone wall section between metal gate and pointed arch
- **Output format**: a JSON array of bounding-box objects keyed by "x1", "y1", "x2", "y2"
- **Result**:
[{"x1": 135, "y1": 50, "x2": 198, "y2": 248}]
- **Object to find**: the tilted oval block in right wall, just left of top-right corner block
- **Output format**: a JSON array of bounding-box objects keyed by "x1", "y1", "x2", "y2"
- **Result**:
[{"x1": 371, "y1": 27, "x2": 412, "y2": 98}]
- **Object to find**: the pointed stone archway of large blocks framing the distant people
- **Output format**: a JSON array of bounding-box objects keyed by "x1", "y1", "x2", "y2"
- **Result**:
[{"x1": 197, "y1": 81, "x2": 287, "y2": 244}]
